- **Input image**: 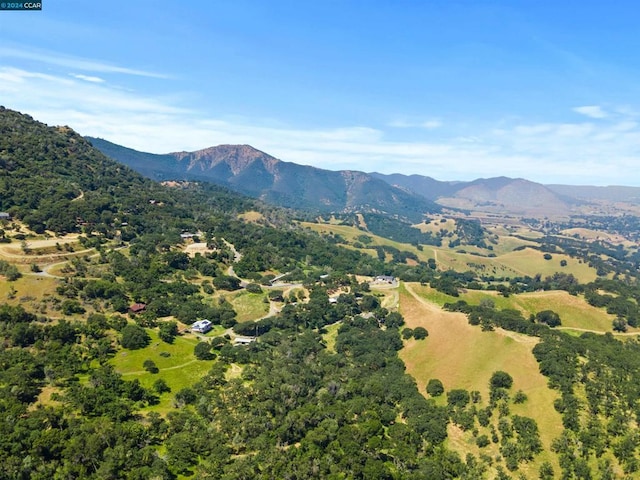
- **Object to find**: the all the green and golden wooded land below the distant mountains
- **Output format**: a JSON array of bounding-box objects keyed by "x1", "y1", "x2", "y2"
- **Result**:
[{"x1": 6, "y1": 109, "x2": 640, "y2": 480}]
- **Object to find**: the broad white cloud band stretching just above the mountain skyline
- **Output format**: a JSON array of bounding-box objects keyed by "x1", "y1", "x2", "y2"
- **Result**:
[{"x1": 0, "y1": 63, "x2": 640, "y2": 185}]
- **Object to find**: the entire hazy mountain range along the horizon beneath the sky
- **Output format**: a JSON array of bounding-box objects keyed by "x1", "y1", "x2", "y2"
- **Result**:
[{"x1": 88, "y1": 137, "x2": 640, "y2": 220}]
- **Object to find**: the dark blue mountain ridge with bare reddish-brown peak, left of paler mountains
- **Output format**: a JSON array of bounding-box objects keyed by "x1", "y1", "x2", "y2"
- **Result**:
[{"x1": 89, "y1": 138, "x2": 441, "y2": 221}]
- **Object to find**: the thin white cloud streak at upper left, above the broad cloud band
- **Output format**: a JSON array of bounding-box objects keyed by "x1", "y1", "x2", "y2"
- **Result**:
[{"x1": 0, "y1": 47, "x2": 168, "y2": 78}]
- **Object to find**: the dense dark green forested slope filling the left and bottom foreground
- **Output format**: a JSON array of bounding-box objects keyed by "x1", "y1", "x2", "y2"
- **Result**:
[{"x1": 0, "y1": 110, "x2": 461, "y2": 479}]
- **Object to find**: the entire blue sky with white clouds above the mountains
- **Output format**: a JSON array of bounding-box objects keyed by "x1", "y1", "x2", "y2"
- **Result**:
[{"x1": 0, "y1": 0, "x2": 640, "y2": 186}]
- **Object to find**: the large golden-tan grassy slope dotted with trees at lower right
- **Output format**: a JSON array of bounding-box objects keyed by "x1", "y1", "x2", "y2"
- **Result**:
[{"x1": 400, "y1": 285, "x2": 562, "y2": 478}]
